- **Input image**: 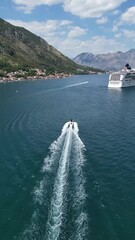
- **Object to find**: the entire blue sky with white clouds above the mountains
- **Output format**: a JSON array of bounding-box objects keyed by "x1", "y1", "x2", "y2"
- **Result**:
[{"x1": 0, "y1": 0, "x2": 135, "y2": 59}]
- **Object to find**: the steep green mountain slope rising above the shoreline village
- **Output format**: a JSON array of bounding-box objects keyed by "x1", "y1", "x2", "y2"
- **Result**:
[{"x1": 0, "y1": 18, "x2": 102, "y2": 73}]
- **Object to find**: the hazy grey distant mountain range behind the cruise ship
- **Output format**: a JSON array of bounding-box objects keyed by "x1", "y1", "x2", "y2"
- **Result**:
[{"x1": 73, "y1": 49, "x2": 135, "y2": 71}]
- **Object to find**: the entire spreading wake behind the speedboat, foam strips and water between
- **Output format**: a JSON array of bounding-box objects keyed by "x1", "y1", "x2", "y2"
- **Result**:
[{"x1": 21, "y1": 122, "x2": 87, "y2": 240}]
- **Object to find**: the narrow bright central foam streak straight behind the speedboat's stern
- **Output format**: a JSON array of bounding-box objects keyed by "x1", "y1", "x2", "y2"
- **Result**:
[{"x1": 45, "y1": 127, "x2": 72, "y2": 240}]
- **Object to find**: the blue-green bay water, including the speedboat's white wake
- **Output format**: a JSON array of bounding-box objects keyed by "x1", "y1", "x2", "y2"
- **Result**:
[{"x1": 0, "y1": 75, "x2": 135, "y2": 240}]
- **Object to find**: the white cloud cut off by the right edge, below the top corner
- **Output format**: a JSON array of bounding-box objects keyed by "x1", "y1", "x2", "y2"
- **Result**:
[{"x1": 120, "y1": 7, "x2": 135, "y2": 24}]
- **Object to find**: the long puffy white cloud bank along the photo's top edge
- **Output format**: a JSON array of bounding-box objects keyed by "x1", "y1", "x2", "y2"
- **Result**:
[{"x1": 12, "y1": 0, "x2": 127, "y2": 18}]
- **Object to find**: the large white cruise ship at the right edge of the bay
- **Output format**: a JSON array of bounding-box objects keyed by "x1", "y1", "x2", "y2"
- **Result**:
[{"x1": 108, "y1": 63, "x2": 135, "y2": 88}]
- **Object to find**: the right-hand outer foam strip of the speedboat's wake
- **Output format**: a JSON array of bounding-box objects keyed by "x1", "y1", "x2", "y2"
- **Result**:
[{"x1": 71, "y1": 132, "x2": 88, "y2": 240}]
